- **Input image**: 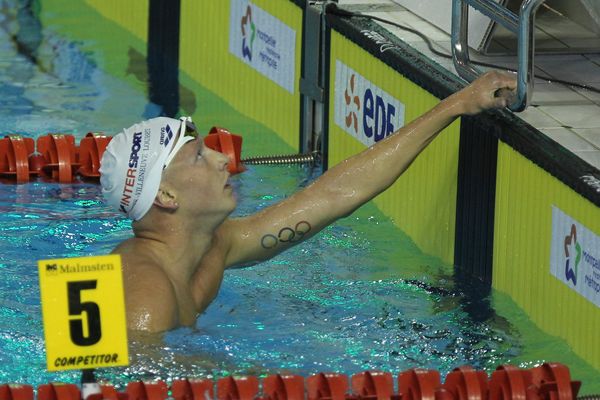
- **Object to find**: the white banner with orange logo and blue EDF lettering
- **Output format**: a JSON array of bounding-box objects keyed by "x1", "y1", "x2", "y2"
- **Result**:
[{"x1": 334, "y1": 60, "x2": 404, "y2": 146}]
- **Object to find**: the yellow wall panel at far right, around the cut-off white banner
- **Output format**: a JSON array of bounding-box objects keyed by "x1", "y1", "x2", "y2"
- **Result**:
[{"x1": 493, "y1": 143, "x2": 600, "y2": 369}]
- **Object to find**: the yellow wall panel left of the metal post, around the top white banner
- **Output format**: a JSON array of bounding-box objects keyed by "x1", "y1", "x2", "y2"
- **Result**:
[{"x1": 179, "y1": 0, "x2": 302, "y2": 149}]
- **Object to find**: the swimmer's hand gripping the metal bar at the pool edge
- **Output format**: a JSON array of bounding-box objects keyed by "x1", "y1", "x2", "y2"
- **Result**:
[{"x1": 456, "y1": 71, "x2": 517, "y2": 115}]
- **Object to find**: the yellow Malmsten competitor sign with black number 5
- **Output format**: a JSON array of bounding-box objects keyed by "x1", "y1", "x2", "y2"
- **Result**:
[{"x1": 38, "y1": 255, "x2": 129, "y2": 371}]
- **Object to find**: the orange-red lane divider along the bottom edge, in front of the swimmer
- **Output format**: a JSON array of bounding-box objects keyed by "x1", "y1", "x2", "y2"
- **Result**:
[{"x1": 0, "y1": 363, "x2": 581, "y2": 400}]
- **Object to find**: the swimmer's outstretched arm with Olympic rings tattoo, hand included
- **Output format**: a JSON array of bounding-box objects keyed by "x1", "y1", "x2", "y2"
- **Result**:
[{"x1": 221, "y1": 72, "x2": 516, "y2": 267}]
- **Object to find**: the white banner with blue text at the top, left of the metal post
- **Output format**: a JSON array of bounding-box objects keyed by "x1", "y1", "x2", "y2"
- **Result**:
[{"x1": 229, "y1": 0, "x2": 296, "y2": 94}]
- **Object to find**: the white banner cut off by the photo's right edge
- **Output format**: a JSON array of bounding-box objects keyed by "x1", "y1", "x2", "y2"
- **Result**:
[{"x1": 550, "y1": 206, "x2": 600, "y2": 307}]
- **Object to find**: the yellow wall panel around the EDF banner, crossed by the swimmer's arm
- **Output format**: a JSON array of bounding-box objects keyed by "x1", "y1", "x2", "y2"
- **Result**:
[{"x1": 329, "y1": 31, "x2": 460, "y2": 264}]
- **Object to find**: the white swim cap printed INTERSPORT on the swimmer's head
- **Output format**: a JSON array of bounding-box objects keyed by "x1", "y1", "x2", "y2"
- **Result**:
[{"x1": 100, "y1": 117, "x2": 194, "y2": 221}]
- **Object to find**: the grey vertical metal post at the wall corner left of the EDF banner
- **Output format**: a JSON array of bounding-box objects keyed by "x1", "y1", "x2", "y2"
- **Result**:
[{"x1": 300, "y1": 1, "x2": 329, "y2": 158}]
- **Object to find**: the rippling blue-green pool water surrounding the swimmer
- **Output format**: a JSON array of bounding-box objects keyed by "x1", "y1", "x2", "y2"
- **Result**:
[{"x1": 0, "y1": 0, "x2": 600, "y2": 393}]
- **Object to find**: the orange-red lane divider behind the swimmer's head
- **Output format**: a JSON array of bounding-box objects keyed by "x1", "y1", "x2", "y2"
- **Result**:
[{"x1": 0, "y1": 127, "x2": 246, "y2": 184}]
